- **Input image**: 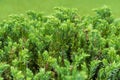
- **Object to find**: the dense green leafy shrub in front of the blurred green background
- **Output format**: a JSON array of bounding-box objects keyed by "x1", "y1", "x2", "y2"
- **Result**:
[{"x1": 0, "y1": 7, "x2": 120, "y2": 80}]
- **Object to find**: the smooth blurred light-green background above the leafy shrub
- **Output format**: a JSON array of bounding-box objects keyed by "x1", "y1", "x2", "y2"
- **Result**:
[{"x1": 0, "y1": 0, "x2": 120, "y2": 20}]
